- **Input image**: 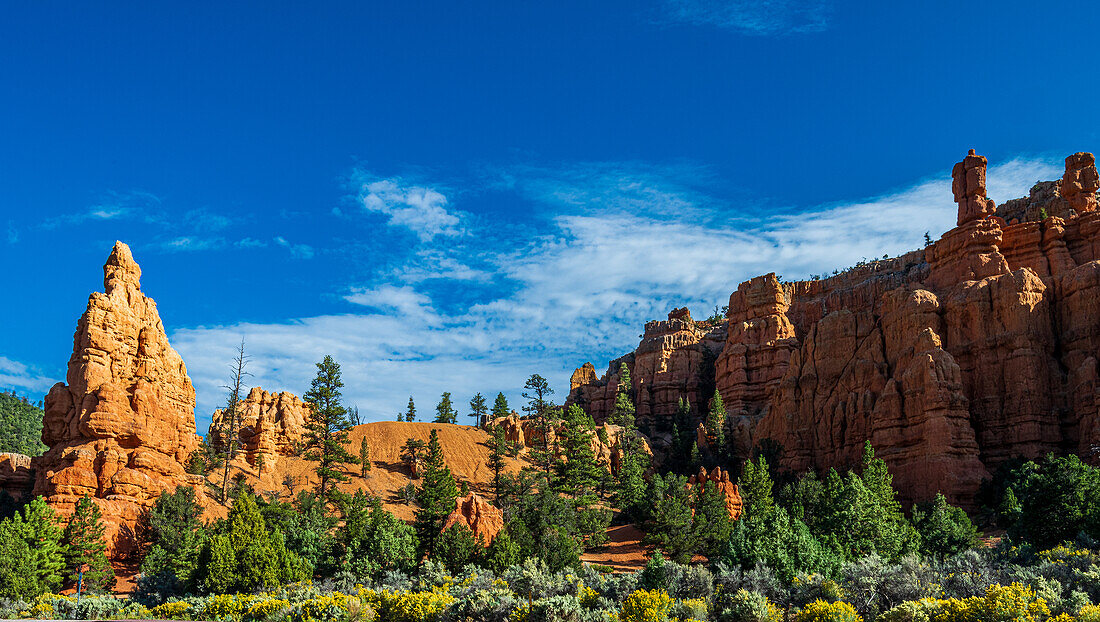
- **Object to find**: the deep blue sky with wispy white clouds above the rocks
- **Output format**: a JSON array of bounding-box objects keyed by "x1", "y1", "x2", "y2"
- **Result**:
[{"x1": 0, "y1": 0, "x2": 1100, "y2": 430}]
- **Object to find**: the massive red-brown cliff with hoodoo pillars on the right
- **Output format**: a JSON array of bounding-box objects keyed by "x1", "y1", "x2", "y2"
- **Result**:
[{"x1": 571, "y1": 151, "x2": 1100, "y2": 505}]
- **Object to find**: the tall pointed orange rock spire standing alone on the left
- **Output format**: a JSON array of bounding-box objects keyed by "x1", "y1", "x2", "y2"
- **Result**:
[{"x1": 34, "y1": 242, "x2": 199, "y2": 554}]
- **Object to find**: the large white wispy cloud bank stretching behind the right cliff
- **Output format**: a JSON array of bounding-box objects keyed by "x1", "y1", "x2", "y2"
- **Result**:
[{"x1": 173, "y1": 154, "x2": 1060, "y2": 431}]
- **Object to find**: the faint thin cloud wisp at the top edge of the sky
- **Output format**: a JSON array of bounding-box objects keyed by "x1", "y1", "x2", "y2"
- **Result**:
[{"x1": 662, "y1": 0, "x2": 833, "y2": 35}]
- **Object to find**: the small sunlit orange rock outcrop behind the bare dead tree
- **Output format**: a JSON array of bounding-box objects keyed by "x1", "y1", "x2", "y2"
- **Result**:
[{"x1": 207, "y1": 386, "x2": 309, "y2": 465}]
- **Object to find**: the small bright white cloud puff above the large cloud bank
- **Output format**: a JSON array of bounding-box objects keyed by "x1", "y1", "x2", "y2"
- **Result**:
[{"x1": 353, "y1": 176, "x2": 462, "y2": 242}]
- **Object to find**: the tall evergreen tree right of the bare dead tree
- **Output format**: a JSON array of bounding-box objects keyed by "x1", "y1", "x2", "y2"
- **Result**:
[{"x1": 304, "y1": 356, "x2": 356, "y2": 499}]
